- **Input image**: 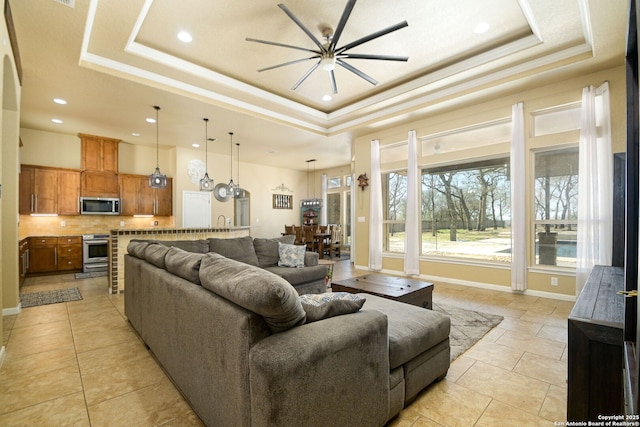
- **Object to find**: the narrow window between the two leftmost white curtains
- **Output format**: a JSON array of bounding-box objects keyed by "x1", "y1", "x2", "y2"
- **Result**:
[{"x1": 382, "y1": 171, "x2": 407, "y2": 253}]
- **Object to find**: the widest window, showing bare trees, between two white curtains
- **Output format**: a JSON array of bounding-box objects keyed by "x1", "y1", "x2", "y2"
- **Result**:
[{"x1": 422, "y1": 158, "x2": 511, "y2": 262}]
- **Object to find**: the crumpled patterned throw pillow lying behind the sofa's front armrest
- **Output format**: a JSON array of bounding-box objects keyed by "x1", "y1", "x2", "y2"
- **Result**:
[{"x1": 300, "y1": 292, "x2": 366, "y2": 323}]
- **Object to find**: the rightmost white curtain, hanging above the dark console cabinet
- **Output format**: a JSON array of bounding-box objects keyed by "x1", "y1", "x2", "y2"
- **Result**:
[{"x1": 576, "y1": 83, "x2": 613, "y2": 296}]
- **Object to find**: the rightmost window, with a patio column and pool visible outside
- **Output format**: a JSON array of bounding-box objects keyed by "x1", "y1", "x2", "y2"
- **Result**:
[{"x1": 534, "y1": 148, "x2": 578, "y2": 268}]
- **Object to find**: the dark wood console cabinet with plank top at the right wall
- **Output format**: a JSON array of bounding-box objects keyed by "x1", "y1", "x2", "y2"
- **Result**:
[{"x1": 567, "y1": 266, "x2": 624, "y2": 421}]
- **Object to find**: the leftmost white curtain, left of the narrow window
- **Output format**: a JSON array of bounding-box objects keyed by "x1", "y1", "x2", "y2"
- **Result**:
[{"x1": 369, "y1": 139, "x2": 382, "y2": 270}]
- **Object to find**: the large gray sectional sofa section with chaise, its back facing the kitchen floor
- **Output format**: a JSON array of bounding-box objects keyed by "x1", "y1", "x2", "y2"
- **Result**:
[{"x1": 125, "y1": 241, "x2": 450, "y2": 427}]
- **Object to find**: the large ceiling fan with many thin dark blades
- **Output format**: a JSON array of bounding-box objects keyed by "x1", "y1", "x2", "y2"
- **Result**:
[{"x1": 246, "y1": 0, "x2": 409, "y2": 94}]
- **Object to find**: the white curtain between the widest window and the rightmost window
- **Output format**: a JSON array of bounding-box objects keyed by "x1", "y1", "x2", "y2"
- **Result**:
[{"x1": 510, "y1": 102, "x2": 527, "y2": 291}]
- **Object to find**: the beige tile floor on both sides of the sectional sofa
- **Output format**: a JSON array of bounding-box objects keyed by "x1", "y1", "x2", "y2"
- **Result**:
[{"x1": 0, "y1": 261, "x2": 573, "y2": 427}]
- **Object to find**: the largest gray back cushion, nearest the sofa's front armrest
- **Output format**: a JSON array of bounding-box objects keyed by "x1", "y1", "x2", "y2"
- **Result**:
[{"x1": 200, "y1": 253, "x2": 305, "y2": 333}]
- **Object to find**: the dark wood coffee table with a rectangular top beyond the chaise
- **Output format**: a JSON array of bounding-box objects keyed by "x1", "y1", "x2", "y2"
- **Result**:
[{"x1": 331, "y1": 274, "x2": 433, "y2": 309}]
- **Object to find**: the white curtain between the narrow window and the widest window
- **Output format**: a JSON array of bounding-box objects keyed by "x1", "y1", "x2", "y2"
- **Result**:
[{"x1": 404, "y1": 130, "x2": 421, "y2": 274}]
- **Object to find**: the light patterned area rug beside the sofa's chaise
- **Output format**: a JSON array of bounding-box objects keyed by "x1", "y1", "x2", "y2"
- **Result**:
[{"x1": 433, "y1": 304, "x2": 504, "y2": 362}]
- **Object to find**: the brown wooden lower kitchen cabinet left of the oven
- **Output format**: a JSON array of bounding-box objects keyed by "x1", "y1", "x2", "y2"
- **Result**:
[{"x1": 28, "y1": 236, "x2": 82, "y2": 273}]
